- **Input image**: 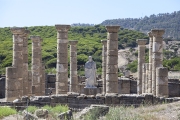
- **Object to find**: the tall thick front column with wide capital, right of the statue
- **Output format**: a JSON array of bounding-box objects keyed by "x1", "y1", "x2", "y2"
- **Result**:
[{"x1": 106, "y1": 26, "x2": 120, "y2": 95}]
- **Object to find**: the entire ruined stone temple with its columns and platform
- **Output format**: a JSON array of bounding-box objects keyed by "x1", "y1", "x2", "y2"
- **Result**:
[{"x1": 0, "y1": 24, "x2": 180, "y2": 107}]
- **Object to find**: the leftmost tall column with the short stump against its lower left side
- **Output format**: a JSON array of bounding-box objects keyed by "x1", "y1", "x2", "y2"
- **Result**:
[{"x1": 6, "y1": 27, "x2": 25, "y2": 101}]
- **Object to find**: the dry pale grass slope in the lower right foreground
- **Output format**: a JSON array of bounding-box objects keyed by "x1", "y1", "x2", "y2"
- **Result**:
[{"x1": 103, "y1": 102, "x2": 180, "y2": 120}]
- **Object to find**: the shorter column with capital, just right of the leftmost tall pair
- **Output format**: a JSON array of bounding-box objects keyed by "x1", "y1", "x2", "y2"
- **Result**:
[{"x1": 30, "y1": 36, "x2": 42, "y2": 95}]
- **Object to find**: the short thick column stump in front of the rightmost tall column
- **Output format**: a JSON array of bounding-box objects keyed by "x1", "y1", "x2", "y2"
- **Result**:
[{"x1": 156, "y1": 67, "x2": 169, "y2": 97}]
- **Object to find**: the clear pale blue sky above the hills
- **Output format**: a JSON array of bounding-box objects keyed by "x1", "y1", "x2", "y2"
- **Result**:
[{"x1": 0, "y1": 0, "x2": 180, "y2": 27}]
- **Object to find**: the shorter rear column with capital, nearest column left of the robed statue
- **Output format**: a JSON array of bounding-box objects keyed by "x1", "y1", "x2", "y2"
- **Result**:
[{"x1": 69, "y1": 40, "x2": 78, "y2": 92}]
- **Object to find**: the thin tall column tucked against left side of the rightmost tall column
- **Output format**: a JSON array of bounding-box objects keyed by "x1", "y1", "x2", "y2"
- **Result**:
[{"x1": 148, "y1": 32, "x2": 153, "y2": 93}]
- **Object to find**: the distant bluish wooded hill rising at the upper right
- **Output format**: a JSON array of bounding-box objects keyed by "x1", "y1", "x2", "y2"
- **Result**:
[{"x1": 101, "y1": 11, "x2": 180, "y2": 40}]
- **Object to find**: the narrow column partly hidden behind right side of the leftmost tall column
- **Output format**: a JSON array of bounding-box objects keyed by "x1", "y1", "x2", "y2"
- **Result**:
[{"x1": 23, "y1": 30, "x2": 31, "y2": 95}]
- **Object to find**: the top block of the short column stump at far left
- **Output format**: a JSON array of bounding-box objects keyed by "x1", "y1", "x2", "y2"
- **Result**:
[{"x1": 6, "y1": 67, "x2": 17, "y2": 79}]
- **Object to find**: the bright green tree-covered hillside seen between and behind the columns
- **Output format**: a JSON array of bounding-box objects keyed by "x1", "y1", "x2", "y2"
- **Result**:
[{"x1": 0, "y1": 25, "x2": 148, "y2": 74}]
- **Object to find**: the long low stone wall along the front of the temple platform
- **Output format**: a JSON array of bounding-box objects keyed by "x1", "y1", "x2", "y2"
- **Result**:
[{"x1": 0, "y1": 94, "x2": 179, "y2": 109}]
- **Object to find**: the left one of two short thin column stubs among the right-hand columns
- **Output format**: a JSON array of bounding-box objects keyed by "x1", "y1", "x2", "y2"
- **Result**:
[{"x1": 142, "y1": 63, "x2": 146, "y2": 94}]
